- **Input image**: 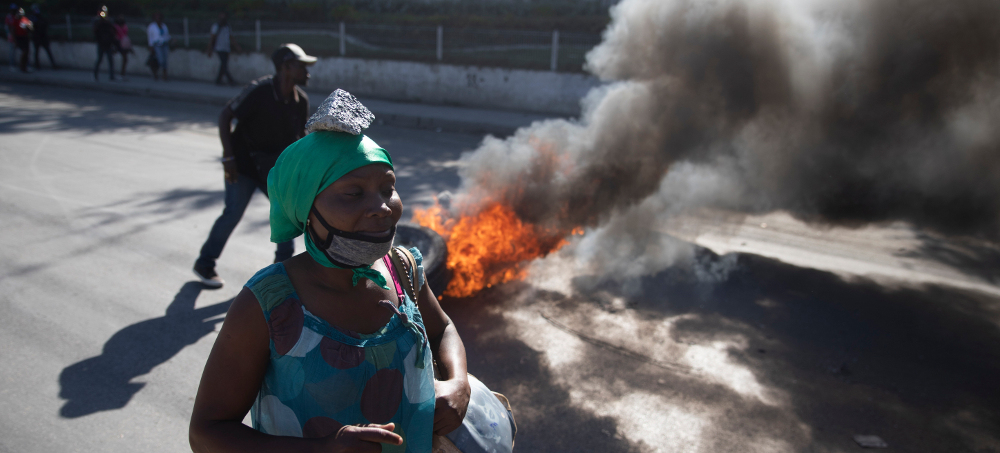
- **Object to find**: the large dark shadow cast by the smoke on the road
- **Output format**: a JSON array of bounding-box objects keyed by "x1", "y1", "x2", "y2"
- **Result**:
[{"x1": 641, "y1": 255, "x2": 1000, "y2": 452}]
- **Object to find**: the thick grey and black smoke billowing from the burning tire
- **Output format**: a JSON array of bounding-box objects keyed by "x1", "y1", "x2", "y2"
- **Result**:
[{"x1": 455, "y1": 0, "x2": 1000, "y2": 284}]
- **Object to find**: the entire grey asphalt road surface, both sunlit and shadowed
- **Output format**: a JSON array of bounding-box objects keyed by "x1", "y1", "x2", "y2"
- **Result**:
[{"x1": 0, "y1": 84, "x2": 1000, "y2": 453}]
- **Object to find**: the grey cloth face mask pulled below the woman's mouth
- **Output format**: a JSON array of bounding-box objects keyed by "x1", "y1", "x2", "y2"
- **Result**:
[{"x1": 309, "y1": 207, "x2": 396, "y2": 269}]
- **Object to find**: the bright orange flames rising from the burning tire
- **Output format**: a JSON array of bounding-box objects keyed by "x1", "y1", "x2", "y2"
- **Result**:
[{"x1": 413, "y1": 202, "x2": 583, "y2": 297}]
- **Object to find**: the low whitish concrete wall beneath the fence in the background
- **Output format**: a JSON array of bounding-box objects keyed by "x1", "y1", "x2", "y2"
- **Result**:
[{"x1": 27, "y1": 43, "x2": 600, "y2": 115}]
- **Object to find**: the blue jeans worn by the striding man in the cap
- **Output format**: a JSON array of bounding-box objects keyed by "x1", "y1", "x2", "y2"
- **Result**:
[{"x1": 194, "y1": 170, "x2": 295, "y2": 269}]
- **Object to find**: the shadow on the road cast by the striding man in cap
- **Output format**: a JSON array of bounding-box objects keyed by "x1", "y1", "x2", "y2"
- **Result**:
[{"x1": 59, "y1": 282, "x2": 232, "y2": 418}]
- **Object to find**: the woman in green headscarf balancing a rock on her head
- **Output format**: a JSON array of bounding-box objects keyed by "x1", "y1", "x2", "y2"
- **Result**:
[{"x1": 190, "y1": 90, "x2": 470, "y2": 452}]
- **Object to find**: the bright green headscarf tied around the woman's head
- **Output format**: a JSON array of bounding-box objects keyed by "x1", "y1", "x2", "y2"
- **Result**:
[{"x1": 267, "y1": 131, "x2": 392, "y2": 289}]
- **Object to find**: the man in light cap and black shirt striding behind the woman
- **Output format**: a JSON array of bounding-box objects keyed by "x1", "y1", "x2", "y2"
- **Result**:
[{"x1": 194, "y1": 44, "x2": 316, "y2": 288}]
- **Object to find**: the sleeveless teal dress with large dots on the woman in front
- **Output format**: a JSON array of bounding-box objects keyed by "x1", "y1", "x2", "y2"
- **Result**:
[{"x1": 246, "y1": 249, "x2": 434, "y2": 453}]
